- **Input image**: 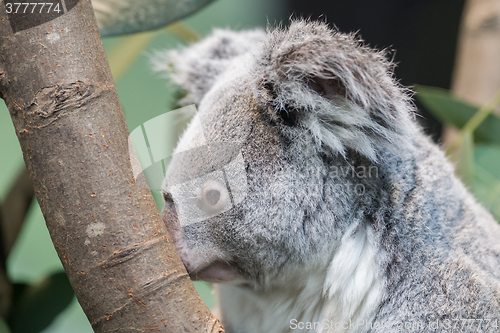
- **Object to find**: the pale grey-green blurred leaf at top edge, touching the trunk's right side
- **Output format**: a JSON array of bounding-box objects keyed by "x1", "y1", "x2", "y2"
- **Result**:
[{"x1": 92, "y1": 0, "x2": 213, "y2": 36}]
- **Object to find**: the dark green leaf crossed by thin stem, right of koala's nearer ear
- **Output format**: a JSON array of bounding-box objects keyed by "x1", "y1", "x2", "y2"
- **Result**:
[{"x1": 416, "y1": 86, "x2": 500, "y2": 144}]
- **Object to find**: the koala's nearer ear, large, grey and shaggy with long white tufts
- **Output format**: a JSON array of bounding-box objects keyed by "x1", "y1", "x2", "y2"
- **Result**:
[{"x1": 255, "y1": 21, "x2": 417, "y2": 160}]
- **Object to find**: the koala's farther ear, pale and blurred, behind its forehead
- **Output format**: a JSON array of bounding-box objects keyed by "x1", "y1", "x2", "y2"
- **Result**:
[{"x1": 153, "y1": 29, "x2": 266, "y2": 105}]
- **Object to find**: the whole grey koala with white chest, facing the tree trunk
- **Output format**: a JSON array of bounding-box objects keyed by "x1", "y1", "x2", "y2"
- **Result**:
[{"x1": 157, "y1": 20, "x2": 500, "y2": 333}]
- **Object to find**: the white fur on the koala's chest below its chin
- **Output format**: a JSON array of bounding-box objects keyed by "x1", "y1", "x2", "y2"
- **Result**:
[{"x1": 218, "y1": 223, "x2": 384, "y2": 333}]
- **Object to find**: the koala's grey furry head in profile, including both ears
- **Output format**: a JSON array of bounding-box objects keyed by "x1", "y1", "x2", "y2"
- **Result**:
[{"x1": 161, "y1": 21, "x2": 417, "y2": 288}]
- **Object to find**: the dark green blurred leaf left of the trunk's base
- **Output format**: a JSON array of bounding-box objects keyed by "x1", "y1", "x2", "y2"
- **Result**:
[{"x1": 9, "y1": 272, "x2": 74, "y2": 333}]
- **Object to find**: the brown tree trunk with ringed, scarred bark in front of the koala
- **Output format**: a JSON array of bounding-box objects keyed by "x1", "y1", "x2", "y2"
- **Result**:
[{"x1": 0, "y1": 0, "x2": 223, "y2": 333}]
